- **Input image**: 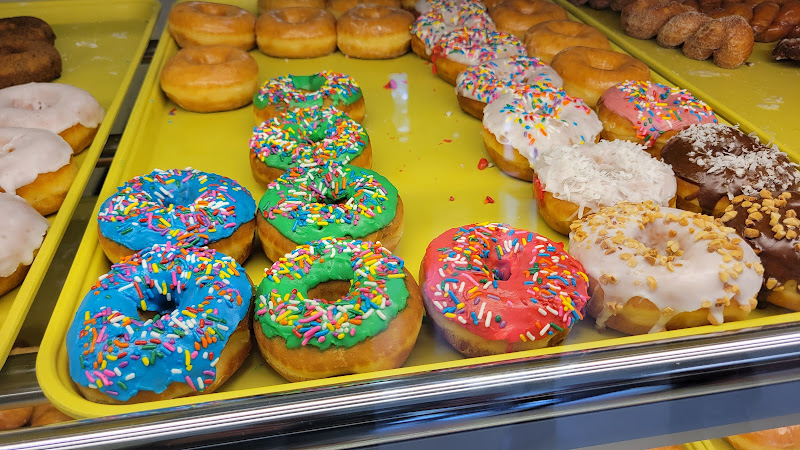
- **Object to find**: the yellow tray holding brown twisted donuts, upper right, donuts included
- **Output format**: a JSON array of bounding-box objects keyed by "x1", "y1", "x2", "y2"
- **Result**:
[{"x1": 556, "y1": 0, "x2": 800, "y2": 155}]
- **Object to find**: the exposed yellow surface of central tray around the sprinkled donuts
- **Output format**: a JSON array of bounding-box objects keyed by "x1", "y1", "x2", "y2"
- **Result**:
[{"x1": 36, "y1": 0, "x2": 800, "y2": 418}]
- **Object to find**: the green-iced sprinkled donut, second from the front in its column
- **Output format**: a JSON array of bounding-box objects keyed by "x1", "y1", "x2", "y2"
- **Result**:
[{"x1": 257, "y1": 161, "x2": 403, "y2": 261}]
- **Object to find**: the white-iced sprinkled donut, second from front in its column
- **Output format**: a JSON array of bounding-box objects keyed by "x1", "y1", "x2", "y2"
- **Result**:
[{"x1": 456, "y1": 56, "x2": 563, "y2": 120}]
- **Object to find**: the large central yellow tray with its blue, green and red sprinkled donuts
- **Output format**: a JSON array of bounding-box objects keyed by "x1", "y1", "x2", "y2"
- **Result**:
[{"x1": 36, "y1": 0, "x2": 798, "y2": 417}]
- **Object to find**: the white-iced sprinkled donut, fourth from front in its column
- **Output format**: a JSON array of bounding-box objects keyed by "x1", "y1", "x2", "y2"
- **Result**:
[{"x1": 411, "y1": 1, "x2": 495, "y2": 61}]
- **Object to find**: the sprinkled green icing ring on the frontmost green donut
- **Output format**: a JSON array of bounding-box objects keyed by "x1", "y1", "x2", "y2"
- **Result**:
[{"x1": 255, "y1": 238, "x2": 409, "y2": 350}]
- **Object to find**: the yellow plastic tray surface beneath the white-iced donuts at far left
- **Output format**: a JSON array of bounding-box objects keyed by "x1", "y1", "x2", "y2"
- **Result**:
[{"x1": 0, "y1": 0, "x2": 161, "y2": 368}]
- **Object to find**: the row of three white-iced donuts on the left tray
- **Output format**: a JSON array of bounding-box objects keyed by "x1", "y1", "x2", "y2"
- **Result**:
[{"x1": 0, "y1": 78, "x2": 105, "y2": 295}]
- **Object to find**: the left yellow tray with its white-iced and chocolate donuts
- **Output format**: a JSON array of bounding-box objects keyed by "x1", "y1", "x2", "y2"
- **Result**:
[{"x1": 0, "y1": 0, "x2": 160, "y2": 367}]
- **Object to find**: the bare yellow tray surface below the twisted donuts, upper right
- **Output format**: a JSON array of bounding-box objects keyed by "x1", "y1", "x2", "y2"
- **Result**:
[{"x1": 554, "y1": 0, "x2": 800, "y2": 156}]
